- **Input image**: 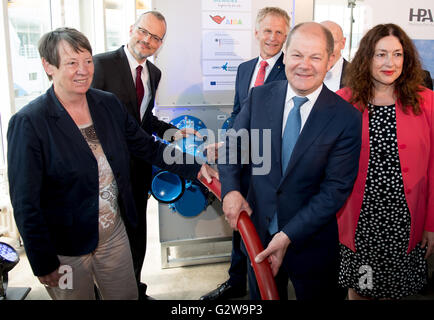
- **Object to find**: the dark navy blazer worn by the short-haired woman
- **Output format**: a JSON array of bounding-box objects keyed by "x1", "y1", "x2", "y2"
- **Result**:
[{"x1": 7, "y1": 87, "x2": 199, "y2": 276}]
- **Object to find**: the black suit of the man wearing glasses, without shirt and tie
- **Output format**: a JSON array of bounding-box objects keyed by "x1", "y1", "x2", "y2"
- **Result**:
[{"x1": 92, "y1": 46, "x2": 176, "y2": 246}]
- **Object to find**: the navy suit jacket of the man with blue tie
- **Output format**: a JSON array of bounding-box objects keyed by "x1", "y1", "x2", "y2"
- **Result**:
[{"x1": 219, "y1": 80, "x2": 362, "y2": 274}]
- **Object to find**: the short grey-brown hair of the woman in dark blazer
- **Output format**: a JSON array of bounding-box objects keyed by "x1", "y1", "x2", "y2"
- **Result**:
[{"x1": 38, "y1": 28, "x2": 92, "y2": 80}]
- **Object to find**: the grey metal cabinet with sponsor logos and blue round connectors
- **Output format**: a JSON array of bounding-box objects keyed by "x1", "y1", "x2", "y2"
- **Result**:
[{"x1": 153, "y1": 0, "x2": 292, "y2": 268}]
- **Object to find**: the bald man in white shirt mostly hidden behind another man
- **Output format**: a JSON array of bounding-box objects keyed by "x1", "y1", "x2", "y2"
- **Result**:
[{"x1": 321, "y1": 20, "x2": 349, "y2": 92}]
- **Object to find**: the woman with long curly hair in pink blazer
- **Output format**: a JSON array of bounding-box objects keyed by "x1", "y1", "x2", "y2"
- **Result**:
[{"x1": 337, "y1": 24, "x2": 434, "y2": 299}]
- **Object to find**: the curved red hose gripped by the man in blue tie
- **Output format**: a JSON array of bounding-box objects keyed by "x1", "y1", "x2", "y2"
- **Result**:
[{"x1": 200, "y1": 177, "x2": 279, "y2": 300}]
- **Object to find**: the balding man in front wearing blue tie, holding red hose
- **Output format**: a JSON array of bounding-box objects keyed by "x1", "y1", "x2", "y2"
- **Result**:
[{"x1": 219, "y1": 22, "x2": 362, "y2": 300}]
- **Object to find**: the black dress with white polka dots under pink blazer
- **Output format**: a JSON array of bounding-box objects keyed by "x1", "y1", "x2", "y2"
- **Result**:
[{"x1": 339, "y1": 105, "x2": 427, "y2": 299}]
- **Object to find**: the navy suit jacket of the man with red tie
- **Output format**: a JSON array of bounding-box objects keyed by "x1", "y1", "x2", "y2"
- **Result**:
[{"x1": 229, "y1": 53, "x2": 286, "y2": 128}]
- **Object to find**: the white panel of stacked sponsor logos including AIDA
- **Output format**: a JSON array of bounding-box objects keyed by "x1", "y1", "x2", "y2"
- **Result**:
[{"x1": 202, "y1": 0, "x2": 253, "y2": 91}]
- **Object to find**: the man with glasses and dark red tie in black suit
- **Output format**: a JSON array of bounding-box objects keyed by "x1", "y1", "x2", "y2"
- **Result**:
[{"x1": 92, "y1": 11, "x2": 192, "y2": 299}]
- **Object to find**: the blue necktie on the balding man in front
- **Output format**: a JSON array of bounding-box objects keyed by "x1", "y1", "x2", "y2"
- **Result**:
[{"x1": 268, "y1": 97, "x2": 309, "y2": 235}]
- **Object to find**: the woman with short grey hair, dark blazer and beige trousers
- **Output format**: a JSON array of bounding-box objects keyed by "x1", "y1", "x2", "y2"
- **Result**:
[{"x1": 7, "y1": 28, "x2": 218, "y2": 300}]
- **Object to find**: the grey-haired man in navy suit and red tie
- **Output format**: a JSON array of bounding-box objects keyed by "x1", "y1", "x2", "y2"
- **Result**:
[{"x1": 201, "y1": 7, "x2": 290, "y2": 300}]
